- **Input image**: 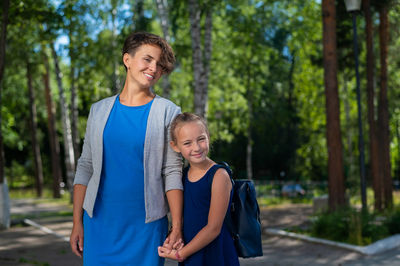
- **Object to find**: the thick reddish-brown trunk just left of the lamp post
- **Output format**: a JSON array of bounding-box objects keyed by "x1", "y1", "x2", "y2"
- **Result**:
[{"x1": 322, "y1": 0, "x2": 345, "y2": 211}]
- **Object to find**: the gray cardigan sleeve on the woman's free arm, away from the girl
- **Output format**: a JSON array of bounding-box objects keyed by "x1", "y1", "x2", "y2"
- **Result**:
[{"x1": 74, "y1": 105, "x2": 93, "y2": 186}]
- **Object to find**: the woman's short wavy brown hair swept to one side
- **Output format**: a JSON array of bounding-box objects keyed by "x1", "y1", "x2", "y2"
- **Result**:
[{"x1": 122, "y1": 32, "x2": 175, "y2": 74}]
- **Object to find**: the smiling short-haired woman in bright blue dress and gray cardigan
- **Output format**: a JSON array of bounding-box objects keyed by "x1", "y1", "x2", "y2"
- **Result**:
[{"x1": 70, "y1": 32, "x2": 183, "y2": 265}]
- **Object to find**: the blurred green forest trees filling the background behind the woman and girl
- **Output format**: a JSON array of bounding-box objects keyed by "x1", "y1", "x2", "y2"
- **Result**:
[{"x1": 0, "y1": 0, "x2": 400, "y2": 210}]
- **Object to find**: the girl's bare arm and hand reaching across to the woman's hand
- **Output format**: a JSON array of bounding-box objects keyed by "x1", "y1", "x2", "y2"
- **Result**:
[{"x1": 158, "y1": 169, "x2": 232, "y2": 260}]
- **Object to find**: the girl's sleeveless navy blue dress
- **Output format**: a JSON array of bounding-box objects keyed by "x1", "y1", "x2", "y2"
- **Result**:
[{"x1": 180, "y1": 165, "x2": 239, "y2": 266}]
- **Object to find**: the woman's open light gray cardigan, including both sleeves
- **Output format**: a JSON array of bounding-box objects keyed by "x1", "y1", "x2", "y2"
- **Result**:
[{"x1": 74, "y1": 95, "x2": 183, "y2": 223}]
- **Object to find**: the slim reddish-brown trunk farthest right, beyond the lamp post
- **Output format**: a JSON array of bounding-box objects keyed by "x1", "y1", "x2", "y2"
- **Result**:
[{"x1": 378, "y1": 5, "x2": 393, "y2": 208}]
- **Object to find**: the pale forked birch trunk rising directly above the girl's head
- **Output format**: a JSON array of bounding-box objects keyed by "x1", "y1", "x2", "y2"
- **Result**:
[{"x1": 188, "y1": 0, "x2": 212, "y2": 117}]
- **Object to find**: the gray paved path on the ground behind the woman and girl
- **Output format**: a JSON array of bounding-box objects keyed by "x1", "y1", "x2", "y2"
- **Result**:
[{"x1": 0, "y1": 200, "x2": 400, "y2": 266}]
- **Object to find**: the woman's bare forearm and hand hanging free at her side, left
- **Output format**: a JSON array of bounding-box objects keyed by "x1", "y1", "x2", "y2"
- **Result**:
[{"x1": 69, "y1": 184, "x2": 87, "y2": 257}]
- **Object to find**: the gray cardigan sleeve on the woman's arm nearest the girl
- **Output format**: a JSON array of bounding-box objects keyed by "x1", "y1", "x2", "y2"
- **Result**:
[{"x1": 162, "y1": 105, "x2": 183, "y2": 192}]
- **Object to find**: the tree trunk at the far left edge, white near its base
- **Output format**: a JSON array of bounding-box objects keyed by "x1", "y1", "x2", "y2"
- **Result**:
[{"x1": 0, "y1": 0, "x2": 11, "y2": 229}]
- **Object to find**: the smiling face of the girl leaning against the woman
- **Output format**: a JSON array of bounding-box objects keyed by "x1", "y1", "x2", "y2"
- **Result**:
[{"x1": 171, "y1": 121, "x2": 210, "y2": 164}]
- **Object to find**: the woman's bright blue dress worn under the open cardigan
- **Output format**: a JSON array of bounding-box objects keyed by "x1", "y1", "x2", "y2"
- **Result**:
[{"x1": 83, "y1": 97, "x2": 168, "y2": 266}]
